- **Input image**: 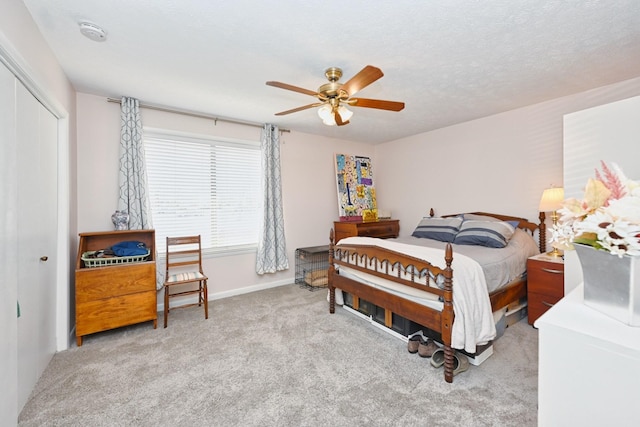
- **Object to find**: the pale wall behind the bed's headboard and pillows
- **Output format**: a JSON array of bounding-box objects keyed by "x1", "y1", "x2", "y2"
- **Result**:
[{"x1": 375, "y1": 74, "x2": 640, "y2": 241}]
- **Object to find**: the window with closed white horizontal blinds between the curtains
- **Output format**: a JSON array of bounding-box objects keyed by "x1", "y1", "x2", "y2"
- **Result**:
[{"x1": 144, "y1": 130, "x2": 262, "y2": 252}]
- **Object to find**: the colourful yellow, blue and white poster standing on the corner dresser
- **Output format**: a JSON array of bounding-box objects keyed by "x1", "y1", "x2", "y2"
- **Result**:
[{"x1": 336, "y1": 154, "x2": 378, "y2": 221}]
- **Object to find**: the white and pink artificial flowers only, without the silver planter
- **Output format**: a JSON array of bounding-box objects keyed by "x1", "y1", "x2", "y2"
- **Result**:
[{"x1": 550, "y1": 161, "x2": 640, "y2": 257}]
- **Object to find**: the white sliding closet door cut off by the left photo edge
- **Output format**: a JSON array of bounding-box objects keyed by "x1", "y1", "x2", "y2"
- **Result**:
[{"x1": 0, "y1": 64, "x2": 18, "y2": 421}]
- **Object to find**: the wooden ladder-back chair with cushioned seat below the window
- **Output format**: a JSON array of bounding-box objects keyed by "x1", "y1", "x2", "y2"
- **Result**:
[{"x1": 164, "y1": 235, "x2": 209, "y2": 328}]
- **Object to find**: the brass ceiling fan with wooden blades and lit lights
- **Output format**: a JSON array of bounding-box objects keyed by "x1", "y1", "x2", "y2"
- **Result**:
[{"x1": 267, "y1": 65, "x2": 404, "y2": 126}]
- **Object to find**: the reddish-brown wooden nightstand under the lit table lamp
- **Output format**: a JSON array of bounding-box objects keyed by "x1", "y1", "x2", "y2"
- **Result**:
[{"x1": 527, "y1": 254, "x2": 564, "y2": 325}]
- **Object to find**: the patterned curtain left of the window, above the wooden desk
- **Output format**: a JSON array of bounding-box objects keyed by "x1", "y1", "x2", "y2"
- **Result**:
[{"x1": 118, "y1": 97, "x2": 152, "y2": 230}]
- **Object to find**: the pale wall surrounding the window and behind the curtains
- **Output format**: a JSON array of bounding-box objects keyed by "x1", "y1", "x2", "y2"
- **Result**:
[{"x1": 73, "y1": 93, "x2": 376, "y2": 298}]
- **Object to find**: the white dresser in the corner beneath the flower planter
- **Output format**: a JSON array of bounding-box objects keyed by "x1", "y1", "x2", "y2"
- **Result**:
[{"x1": 535, "y1": 284, "x2": 640, "y2": 427}]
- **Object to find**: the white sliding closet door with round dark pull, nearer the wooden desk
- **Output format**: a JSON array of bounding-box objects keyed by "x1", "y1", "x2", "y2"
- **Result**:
[{"x1": 16, "y1": 79, "x2": 58, "y2": 409}]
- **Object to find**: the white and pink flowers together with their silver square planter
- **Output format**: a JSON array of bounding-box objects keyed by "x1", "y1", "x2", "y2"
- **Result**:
[{"x1": 552, "y1": 162, "x2": 640, "y2": 327}]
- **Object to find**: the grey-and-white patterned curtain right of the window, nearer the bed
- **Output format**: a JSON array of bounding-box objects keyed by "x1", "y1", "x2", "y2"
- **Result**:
[{"x1": 256, "y1": 123, "x2": 289, "y2": 274}]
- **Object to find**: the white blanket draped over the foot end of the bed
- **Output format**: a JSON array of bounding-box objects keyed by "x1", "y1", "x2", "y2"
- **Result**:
[{"x1": 337, "y1": 237, "x2": 496, "y2": 353}]
